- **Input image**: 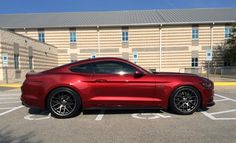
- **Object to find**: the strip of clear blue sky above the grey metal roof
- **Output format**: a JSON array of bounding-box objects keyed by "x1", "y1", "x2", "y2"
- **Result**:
[{"x1": 0, "y1": 0, "x2": 236, "y2": 14}]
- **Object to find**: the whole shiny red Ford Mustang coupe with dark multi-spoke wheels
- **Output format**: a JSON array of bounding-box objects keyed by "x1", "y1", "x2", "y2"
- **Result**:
[{"x1": 21, "y1": 58, "x2": 214, "y2": 118}]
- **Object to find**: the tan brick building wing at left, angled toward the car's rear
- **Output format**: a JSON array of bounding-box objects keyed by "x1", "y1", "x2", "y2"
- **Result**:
[{"x1": 0, "y1": 29, "x2": 58, "y2": 82}]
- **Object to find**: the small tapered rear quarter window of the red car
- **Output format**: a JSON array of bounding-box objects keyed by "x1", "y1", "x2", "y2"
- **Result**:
[{"x1": 70, "y1": 64, "x2": 93, "y2": 74}]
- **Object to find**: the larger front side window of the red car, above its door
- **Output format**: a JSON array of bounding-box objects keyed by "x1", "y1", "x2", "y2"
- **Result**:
[{"x1": 94, "y1": 61, "x2": 136, "y2": 74}]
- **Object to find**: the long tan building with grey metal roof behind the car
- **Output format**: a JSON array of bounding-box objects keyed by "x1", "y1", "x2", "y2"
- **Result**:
[{"x1": 0, "y1": 9, "x2": 236, "y2": 75}]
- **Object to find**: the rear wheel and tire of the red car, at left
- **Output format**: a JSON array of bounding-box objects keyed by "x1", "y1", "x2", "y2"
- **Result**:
[{"x1": 47, "y1": 87, "x2": 81, "y2": 118}]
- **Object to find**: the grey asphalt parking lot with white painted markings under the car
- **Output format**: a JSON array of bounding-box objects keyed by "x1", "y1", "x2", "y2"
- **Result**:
[{"x1": 0, "y1": 86, "x2": 236, "y2": 143}]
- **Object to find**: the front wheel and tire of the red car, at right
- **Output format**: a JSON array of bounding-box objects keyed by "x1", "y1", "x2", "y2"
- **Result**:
[{"x1": 169, "y1": 86, "x2": 201, "y2": 115}]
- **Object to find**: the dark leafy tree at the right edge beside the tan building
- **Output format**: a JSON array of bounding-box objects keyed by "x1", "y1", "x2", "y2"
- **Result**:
[{"x1": 223, "y1": 25, "x2": 236, "y2": 65}]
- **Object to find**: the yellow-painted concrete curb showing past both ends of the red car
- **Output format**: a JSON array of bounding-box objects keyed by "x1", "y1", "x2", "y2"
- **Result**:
[{"x1": 0, "y1": 81, "x2": 236, "y2": 88}]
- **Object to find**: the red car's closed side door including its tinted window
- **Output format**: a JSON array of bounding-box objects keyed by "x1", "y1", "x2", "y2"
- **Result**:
[{"x1": 91, "y1": 61, "x2": 158, "y2": 107}]
